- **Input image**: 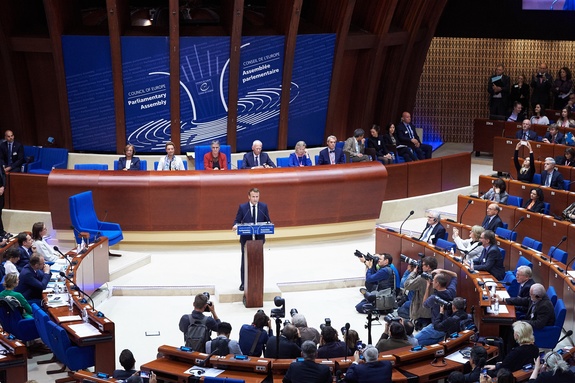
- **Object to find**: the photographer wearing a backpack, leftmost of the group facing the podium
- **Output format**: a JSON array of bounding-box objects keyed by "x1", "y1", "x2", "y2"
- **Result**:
[{"x1": 179, "y1": 292, "x2": 220, "y2": 352}]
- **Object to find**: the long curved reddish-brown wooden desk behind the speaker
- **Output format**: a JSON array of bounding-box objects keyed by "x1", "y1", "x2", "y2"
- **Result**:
[{"x1": 48, "y1": 162, "x2": 387, "y2": 231}]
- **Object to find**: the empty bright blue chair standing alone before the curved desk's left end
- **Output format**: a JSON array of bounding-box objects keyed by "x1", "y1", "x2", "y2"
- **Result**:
[{"x1": 69, "y1": 191, "x2": 124, "y2": 246}]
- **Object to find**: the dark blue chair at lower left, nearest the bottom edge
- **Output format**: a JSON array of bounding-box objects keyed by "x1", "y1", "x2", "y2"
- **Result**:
[{"x1": 47, "y1": 321, "x2": 94, "y2": 371}]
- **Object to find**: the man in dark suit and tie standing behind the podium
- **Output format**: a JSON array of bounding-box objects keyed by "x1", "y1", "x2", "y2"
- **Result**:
[{"x1": 232, "y1": 188, "x2": 271, "y2": 291}]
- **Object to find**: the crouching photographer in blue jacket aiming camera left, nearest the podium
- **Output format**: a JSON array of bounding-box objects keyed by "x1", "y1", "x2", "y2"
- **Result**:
[{"x1": 355, "y1": 251, "x2": 395, "y2": 314}]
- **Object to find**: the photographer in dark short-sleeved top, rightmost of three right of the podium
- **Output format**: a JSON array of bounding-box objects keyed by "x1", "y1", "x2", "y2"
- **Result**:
[{"x1": 415, "y1": 269, "x2": 457, "y2": 346}]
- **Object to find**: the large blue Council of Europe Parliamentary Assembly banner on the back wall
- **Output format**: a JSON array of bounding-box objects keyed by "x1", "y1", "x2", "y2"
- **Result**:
[{"x1": 61, "y1": 34, "x2": 335, "y2": 153}]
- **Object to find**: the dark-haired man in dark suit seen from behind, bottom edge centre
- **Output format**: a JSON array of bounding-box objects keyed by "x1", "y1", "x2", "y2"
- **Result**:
[{"x1": 283, "y1": 340, "x2": 333, "y2": 383}]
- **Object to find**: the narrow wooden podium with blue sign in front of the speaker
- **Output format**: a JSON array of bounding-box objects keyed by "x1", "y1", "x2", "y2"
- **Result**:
[{"x1": 237, "y1": 222, "x2": 274, "y2": 308}]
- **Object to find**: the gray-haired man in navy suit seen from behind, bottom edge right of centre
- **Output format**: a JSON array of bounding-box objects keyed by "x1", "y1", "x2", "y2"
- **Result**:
[{"x1": 345, "y1": 346, "x2": 391, "y2": 383}]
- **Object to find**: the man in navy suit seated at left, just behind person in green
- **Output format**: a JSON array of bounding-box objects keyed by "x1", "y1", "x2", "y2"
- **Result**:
[{"x1": 14, "y1": 254, "x2": 52, "y2": 306}]
